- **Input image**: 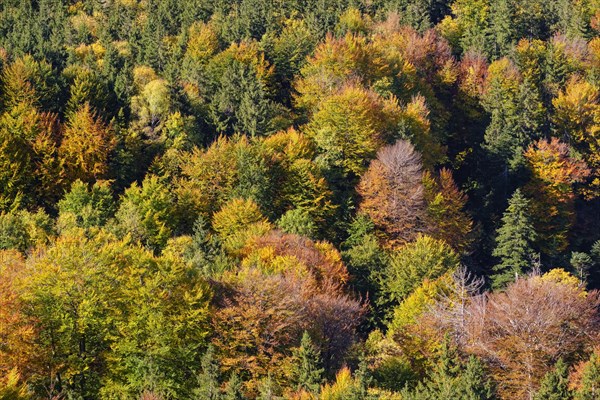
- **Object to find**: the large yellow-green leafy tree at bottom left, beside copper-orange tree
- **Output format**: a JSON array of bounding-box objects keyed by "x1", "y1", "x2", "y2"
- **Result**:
[{"x1": 98, "y1": 236, "x2": 212, "y2": 398}]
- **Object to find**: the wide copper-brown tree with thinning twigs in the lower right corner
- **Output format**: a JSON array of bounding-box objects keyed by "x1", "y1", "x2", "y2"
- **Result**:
[{"x1": 464, "y1": 270, "x2": 599, "y2": 398}]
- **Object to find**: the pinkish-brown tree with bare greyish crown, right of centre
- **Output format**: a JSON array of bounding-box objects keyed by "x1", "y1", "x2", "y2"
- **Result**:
[{"x1": 357, "y1": 140, "x2": 427, "y2": 247}]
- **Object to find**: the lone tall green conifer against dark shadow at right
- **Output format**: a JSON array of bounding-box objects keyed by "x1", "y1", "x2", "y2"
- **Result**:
[{"x1": 492, "y1": 189, "x2": 536, "y2": 288}]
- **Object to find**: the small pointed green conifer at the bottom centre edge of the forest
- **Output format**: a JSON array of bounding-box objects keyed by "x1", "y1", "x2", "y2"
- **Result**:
[{"x1": 292, "y1": 331, "x2": 324, "y2": 394}]
